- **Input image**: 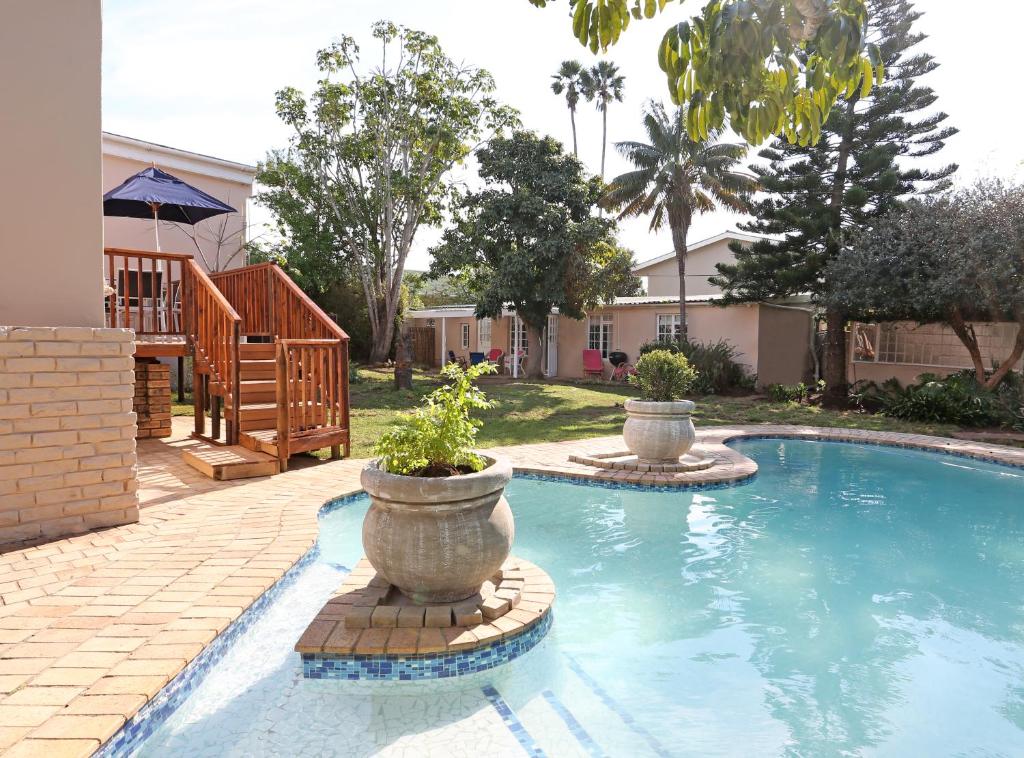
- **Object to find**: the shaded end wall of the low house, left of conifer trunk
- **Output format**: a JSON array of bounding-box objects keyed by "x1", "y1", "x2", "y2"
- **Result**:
[{"x1": 758, "y1": 304, "x2": 813, "y2": 387}]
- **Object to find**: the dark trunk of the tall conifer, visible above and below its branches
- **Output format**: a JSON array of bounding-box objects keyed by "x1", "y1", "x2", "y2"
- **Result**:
[{"x1": 822, "y1": 94, "x2": 859, "y2": 408}]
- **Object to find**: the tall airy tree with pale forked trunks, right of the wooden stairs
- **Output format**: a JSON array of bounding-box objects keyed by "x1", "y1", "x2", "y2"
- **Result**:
[{"x1": 276, "y1": 22, "x2": 517, "y2": 363}]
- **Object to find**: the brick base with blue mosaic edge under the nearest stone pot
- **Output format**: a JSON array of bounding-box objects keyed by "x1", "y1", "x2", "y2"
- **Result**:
[{"x1": 295, "y1": 556, "x2": 555, "y2": 680}]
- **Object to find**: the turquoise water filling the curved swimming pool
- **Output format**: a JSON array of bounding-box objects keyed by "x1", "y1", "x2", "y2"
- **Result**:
[{"x1": 128, "y1": 439, "x2": 1024, "y2": 756}]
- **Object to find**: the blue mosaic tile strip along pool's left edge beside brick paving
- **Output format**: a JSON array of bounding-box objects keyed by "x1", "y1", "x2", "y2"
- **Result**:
[{"x1": 93, "y1": 493, "x2": 365, "y2": 758}]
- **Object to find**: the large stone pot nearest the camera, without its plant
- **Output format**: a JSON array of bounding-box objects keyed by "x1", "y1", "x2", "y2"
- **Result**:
[{"x1": 360, "y1": 458, "x2": 515, "y2": 603}]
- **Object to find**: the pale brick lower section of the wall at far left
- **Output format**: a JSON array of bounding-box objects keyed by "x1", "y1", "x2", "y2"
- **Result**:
[{"x1": 0, "y1": 327, "x2": 138, "y2": 545}]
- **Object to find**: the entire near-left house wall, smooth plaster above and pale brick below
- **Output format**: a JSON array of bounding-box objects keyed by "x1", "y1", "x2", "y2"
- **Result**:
[{"x1": 0, "y1": 0, "x2": 138, "y2": 545}]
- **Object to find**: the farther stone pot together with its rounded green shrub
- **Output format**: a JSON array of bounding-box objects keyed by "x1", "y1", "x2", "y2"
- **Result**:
[{"x1": 623, "y1": 350, "x2": 697, "y2": 463}]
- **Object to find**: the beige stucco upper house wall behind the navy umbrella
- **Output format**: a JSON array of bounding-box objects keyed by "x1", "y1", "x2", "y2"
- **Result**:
[{"x1": 103, "y1": 153, "x2": 253, "y2": 270}]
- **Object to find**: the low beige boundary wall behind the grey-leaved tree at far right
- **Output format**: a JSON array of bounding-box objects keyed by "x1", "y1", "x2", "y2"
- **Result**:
[{"x1": 847, "y1": 322, "x2": 1024, "y2": 384}]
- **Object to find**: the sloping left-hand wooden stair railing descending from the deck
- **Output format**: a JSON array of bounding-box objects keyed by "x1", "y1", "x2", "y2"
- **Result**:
[{"x1": 182, "y1": 259, "x2": 242, "y2": 445}]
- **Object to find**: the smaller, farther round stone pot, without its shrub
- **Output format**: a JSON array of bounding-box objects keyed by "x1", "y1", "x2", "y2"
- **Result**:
[{"x1": 623, "y1": 399, "x2": 695, "y2": 464}]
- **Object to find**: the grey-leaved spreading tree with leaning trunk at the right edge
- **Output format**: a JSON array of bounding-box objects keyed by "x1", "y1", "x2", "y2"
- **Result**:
[{"x1": 825, "y1": 180, "x2": 1024, "y2": 389}]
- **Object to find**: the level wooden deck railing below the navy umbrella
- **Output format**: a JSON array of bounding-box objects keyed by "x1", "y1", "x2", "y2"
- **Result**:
[{"x1": 103, "y1": 248, "x2": 193, "y2": 341}]
